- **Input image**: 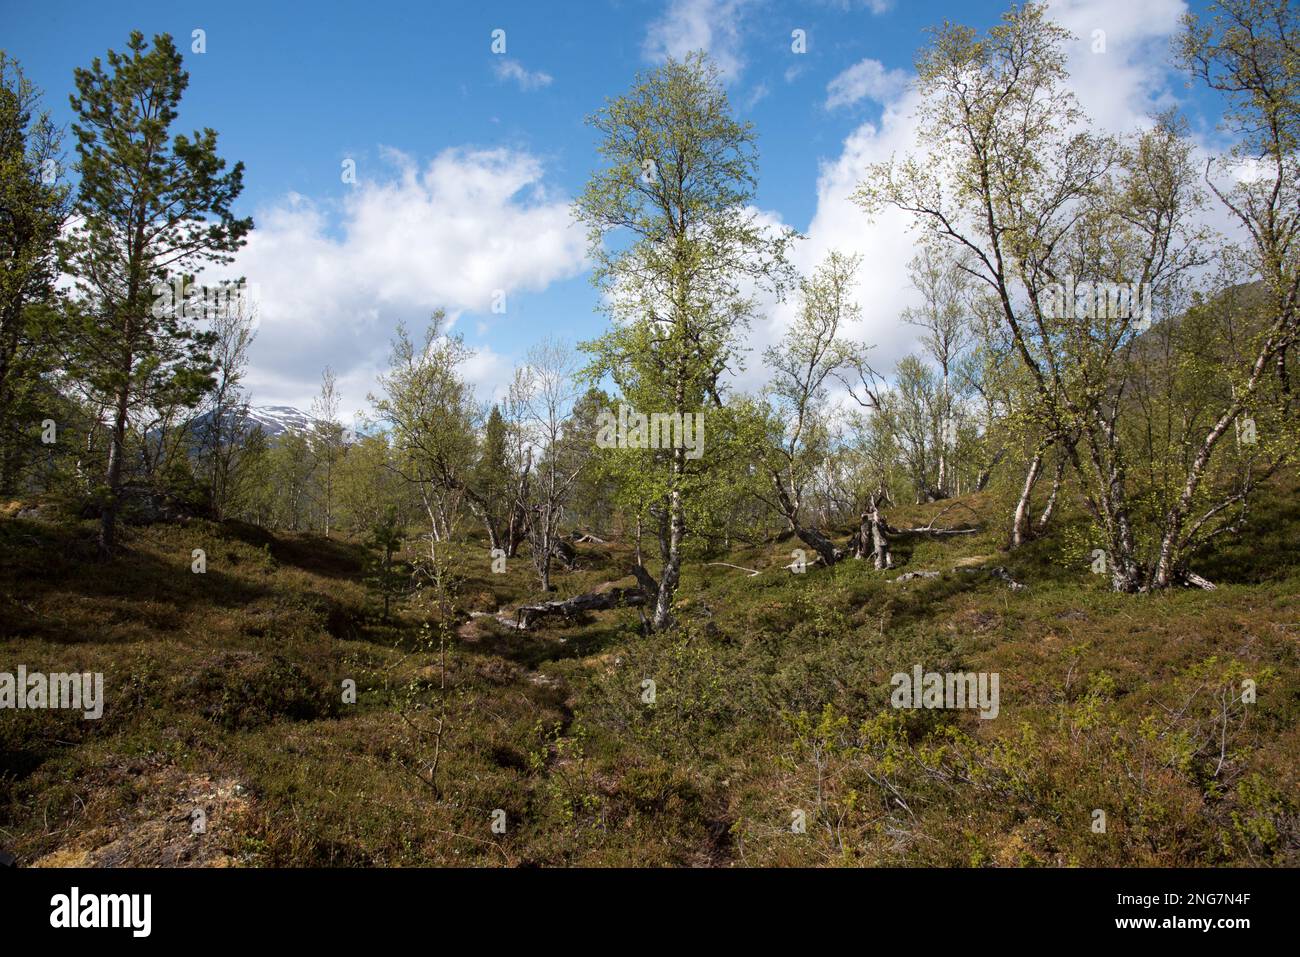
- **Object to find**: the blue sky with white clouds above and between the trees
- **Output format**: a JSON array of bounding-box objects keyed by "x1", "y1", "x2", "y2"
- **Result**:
[{"x1": 0, "y1": 0, "x2": 1213, "y2": 410}]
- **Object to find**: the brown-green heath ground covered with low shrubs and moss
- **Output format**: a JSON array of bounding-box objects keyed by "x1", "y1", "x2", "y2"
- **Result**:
[{"x1": 0, "y1": 486, "x2": 1300, "y2": 866}]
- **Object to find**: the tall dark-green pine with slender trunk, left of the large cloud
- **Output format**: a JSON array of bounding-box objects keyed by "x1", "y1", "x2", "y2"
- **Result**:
[{"x1": 65, "y1": 31, "x2": 252, "y2": 553}]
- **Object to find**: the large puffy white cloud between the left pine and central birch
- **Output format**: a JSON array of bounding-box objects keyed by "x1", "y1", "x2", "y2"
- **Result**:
[{"x1": 211, "y1": 148, "x2": 586, "y2": 410}]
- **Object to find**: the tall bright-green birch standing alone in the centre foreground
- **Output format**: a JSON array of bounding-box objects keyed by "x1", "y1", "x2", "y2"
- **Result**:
[{"x1": 575, "y1": 53, "x2": 792, "y2": 631}]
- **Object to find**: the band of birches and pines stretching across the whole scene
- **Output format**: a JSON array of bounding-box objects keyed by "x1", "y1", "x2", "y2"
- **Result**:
[{"x1": 0, "y1": 0, "x2": 1300, "y2": 628}]
